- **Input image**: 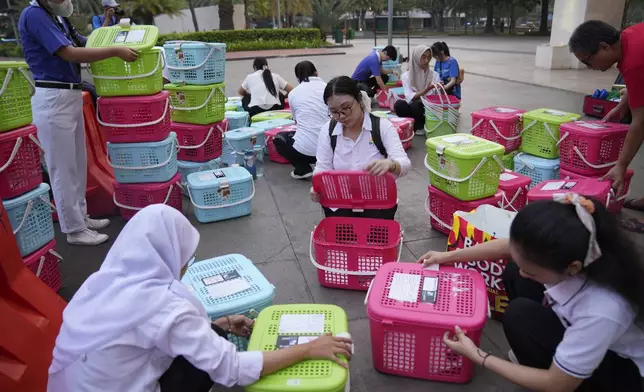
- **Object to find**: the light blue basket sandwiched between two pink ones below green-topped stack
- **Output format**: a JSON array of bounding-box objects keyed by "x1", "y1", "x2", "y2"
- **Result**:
[{"x1": 107, "y1": 132, "x2": 178, "y2": 184}]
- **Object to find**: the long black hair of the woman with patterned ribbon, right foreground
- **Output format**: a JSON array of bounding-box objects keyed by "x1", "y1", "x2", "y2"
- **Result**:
[{"x1": 510, "y1": 201, "x2": 644, "y2": 309}]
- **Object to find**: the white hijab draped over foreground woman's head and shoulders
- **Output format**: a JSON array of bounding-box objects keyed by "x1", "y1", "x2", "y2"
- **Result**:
[{"x1": 49, "y1": 204, "x2": 206, "y2": 374}]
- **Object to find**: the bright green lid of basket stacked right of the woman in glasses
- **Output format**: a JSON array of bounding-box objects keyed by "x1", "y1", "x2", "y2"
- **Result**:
[{"x1": 425, "y1": 133, "x2": 505, "y2": 159}]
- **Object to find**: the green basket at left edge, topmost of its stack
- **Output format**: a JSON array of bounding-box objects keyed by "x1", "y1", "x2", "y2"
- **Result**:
[{"x1": 0, "y1": 61, "x2": 36, "y2": 132}]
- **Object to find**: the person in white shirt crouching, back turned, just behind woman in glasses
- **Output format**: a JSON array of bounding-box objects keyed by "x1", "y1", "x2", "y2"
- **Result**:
[{"x1": 273, "y1": 61, "x2": 329, "y2": 180}]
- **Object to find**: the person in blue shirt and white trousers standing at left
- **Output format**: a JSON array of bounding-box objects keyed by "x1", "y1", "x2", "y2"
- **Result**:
[{"x1": 18, "y1": 0, "x2": 138, "y2": 245}]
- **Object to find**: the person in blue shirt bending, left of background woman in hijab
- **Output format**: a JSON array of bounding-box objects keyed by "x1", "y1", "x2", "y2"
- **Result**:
[{"x1": 351, "y1": 45, "x2": 398, "y2": 97}]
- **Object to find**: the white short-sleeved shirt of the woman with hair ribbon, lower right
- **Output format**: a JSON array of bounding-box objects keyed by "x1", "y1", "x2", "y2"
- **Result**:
[{"x1": 545, "y1": 276, "x2": 644, "y2": 379}]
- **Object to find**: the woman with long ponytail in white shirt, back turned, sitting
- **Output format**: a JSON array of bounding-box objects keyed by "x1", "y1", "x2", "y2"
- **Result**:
[{"x1": 237, "y1": 57, "x2": 293, "y2": 118}]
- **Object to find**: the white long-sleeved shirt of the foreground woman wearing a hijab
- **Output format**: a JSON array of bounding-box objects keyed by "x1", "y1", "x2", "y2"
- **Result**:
[{"x1": 47, "y1": 296, "x2": 263, "y2": 392}]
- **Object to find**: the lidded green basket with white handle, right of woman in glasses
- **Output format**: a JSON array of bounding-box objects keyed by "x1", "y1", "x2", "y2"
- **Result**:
[{"x1": 425, "y1": 133, "x2": 505, "y2": 201}]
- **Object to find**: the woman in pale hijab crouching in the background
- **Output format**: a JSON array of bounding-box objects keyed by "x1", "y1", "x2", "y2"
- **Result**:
[{"x1": 394, "y1": 45, "x2": 440, "y2": 135}]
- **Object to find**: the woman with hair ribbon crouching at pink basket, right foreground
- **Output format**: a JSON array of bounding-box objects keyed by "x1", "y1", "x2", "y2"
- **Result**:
[{"x1": 419, "y1": 194, "x2": 644, "y2": 392}]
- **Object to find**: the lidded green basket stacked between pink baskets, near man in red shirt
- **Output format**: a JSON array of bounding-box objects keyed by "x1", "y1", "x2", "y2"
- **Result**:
[{"x1": 521, "y1": 109, "x2": 581, "y2": 159}]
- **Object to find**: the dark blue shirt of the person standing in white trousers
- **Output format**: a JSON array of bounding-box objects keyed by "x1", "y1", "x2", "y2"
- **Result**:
[{"x1": 18, "y1": 5, "x2": 86, "y2": 83}]
